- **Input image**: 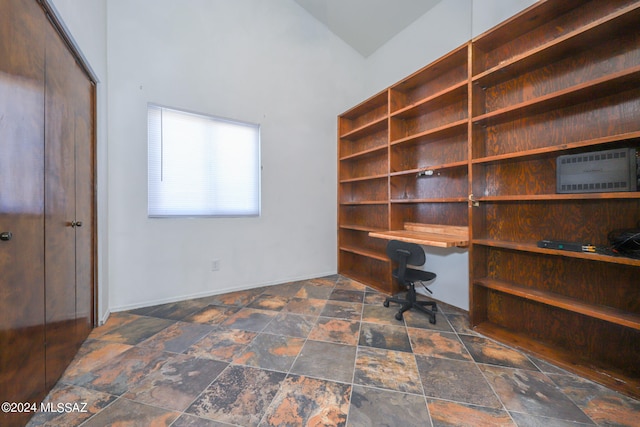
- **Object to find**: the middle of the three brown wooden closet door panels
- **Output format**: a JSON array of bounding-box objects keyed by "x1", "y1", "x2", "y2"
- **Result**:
[{"x1": 45, "y1": 25, "x2": 77, "y2": 387}]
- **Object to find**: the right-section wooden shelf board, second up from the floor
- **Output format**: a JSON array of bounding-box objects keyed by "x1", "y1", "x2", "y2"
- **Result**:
[{"x1": 473, "y1": 278, "x2": 640, "y2": 330}]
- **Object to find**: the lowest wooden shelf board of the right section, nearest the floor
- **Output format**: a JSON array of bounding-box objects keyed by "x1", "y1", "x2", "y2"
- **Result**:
[{"x1": 473, "y1": 322, "x2": 640, "y2": 399}]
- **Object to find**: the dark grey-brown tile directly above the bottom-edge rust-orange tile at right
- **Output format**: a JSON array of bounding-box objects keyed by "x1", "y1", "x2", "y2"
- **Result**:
[{"x1": 415, "y1": 355, "x2": 502, "y2": 408}]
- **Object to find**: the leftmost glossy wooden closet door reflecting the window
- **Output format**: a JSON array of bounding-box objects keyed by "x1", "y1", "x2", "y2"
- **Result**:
[{"x1": 0, "y1": 0, "x2": 49, "y2": 426}]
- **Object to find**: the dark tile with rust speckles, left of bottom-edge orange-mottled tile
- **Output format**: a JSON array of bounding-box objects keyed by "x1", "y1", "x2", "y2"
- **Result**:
[{"x1": 185, "y1": 365, "x2": 286, "y2": 427}]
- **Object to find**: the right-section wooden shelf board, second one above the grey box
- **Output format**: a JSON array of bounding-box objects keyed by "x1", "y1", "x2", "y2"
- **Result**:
[{"x1": 472, "y1": 65, "x2": 640, "y2": 125}]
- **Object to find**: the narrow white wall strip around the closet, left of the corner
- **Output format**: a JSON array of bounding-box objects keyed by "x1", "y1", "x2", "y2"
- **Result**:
[{"x1": 52, "y1": 0, "x2": 109, "y2": 321}]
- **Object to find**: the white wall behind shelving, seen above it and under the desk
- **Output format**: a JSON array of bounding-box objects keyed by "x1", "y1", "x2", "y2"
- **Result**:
[{"x1": 363, "y1": 0, "x2": 535, "y2": 310}]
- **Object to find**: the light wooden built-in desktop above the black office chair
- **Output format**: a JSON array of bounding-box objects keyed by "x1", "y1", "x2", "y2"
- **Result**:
[{"x1": 369, "y1": 222, "x2": 469, "y2": 248}]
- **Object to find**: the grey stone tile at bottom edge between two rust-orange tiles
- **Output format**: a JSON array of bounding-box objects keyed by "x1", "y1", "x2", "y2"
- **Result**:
[{"x1": 347, "y1": 385, "x2": 429, "y2": 427}]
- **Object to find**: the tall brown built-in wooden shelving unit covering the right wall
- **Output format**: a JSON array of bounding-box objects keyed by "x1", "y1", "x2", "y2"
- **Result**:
[{"x1": 338, "y1": 0, "x2": 640, "y2": 397}]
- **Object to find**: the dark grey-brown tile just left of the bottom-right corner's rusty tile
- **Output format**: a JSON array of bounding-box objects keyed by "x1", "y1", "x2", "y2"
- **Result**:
[{"x1": 480, "y1": 365, "x2": 590, "y2": 423}]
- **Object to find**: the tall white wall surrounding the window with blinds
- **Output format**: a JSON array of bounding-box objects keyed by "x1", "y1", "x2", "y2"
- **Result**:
[{"x1": 107, "y1": 0, "x2": 364, "y2": 311}]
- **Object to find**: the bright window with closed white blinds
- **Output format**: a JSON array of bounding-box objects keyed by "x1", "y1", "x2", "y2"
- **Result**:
[{"x1": 147, "y1": 104, "x2": 260, "y2": 217}]
